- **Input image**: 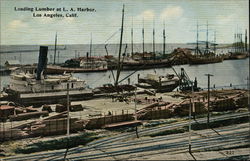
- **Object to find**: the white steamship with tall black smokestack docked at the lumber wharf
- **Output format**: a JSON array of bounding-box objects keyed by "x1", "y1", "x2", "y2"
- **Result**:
[{"x1": 5, "y1": 46, "x2": 93, "y2": 106}]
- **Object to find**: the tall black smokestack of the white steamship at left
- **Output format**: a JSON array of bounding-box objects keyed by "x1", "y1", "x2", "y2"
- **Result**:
[{"x1": 36, "y1": 46, "x2": 48, "y2": 80}]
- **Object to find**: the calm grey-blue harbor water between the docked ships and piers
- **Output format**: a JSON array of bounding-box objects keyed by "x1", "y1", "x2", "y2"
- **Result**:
[{"x1": 0, "y1": 44, "x2": 249, "y2": 88}]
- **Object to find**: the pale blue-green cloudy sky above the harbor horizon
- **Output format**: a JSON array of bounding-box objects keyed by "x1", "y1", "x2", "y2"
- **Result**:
[{"x1": 0, "y1": 0, "x2": 249, "y2": 45}]
